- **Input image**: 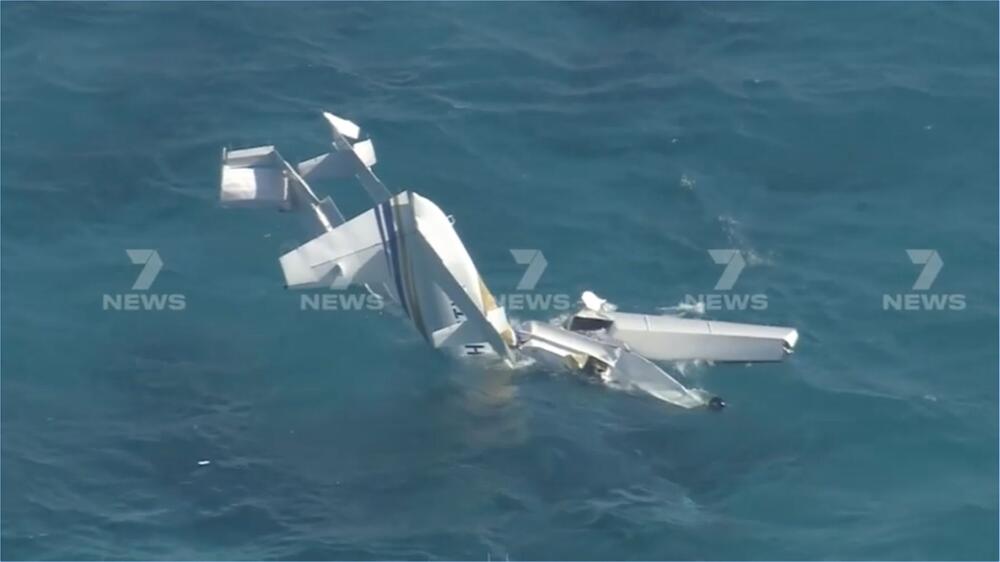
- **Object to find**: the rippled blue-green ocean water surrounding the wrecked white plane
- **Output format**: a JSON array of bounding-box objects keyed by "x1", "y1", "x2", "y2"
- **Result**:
[{"x1": 0, "y1": 2, "x2": 1000, "y2": 560}]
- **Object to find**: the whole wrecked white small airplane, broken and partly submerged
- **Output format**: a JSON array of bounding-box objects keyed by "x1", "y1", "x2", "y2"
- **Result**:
[{"x1": 219, "y1": 113, "x2": 798, "y2": 410}]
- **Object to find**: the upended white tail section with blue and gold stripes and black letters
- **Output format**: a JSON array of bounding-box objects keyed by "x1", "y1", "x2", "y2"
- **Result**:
[{"x1": 280, "y1": 192, "x2": 514, "y2": 358}]
